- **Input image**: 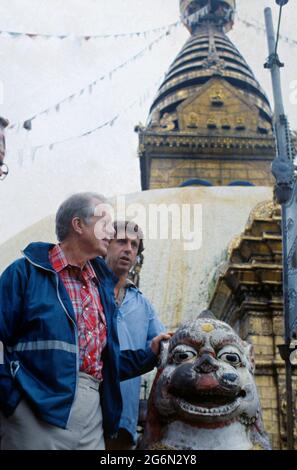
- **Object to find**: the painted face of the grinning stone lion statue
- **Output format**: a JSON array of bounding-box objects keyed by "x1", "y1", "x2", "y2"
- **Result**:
[{"x1": 154, "y1": 318, "x2": 260, "y2": 426}]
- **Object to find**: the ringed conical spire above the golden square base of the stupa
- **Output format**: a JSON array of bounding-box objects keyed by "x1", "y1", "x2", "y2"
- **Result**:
[{"x1": 148, "y1": 0, "x2": 272, "y2": 130}]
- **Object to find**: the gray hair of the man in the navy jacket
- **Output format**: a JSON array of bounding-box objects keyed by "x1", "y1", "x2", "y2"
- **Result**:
[{"x1": 56, "y1": 192, "x2": 106, "y2": 242}]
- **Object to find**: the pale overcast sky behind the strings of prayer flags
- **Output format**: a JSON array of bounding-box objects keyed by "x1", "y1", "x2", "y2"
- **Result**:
[{"x1": 0, "y1": 0, "x2": 297, "y2": 242}]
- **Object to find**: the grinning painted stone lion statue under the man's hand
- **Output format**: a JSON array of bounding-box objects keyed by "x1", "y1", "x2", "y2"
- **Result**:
[{"x1": 139, "y1": 311, "x2": 270, "y2": 450}]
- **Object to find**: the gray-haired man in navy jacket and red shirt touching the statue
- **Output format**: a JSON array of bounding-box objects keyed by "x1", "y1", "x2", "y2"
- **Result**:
[{"x1": 0, "y1": 193, "x2": 166, "y2": 450}]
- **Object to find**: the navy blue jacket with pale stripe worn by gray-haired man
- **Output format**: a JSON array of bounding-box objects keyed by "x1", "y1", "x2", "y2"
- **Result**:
[{"x1": 0, "y1": 243, "x2": 157, "y2": 437}]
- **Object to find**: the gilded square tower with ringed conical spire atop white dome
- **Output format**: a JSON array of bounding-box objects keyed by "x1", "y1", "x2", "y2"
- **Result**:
[{"x1": 136, "y1": 0, "x2": 275, "y2": 190}]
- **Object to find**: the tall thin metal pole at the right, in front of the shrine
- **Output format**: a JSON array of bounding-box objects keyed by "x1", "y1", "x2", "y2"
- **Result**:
[{"x1": 265, "y1": 8, "x2": 294, "y2": 450}]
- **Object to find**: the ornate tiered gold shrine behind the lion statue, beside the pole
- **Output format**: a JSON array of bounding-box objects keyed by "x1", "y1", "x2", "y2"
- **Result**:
[{"x1": 209, "y1": 202, "x2": 297, "y2": 449}]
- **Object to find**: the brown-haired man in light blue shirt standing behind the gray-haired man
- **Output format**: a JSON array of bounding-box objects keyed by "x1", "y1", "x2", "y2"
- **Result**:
[{"x1": 106, "y1": 221, "x2": 165, "y2": 450}]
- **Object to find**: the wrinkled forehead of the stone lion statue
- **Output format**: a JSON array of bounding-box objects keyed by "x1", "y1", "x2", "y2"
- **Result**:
[{"x1": 170, "y1": 319, "x2": 244, "y2": 351}]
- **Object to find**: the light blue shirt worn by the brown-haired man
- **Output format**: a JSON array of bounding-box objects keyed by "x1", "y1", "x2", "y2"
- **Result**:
[{"x1": 118, "y1": 286, "x2": 165, "y2": 440}]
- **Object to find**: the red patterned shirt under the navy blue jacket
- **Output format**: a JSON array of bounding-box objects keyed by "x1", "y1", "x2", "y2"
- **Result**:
[{"x1": 49, "y1": 245, "x2": 107, "y2": 380}]
